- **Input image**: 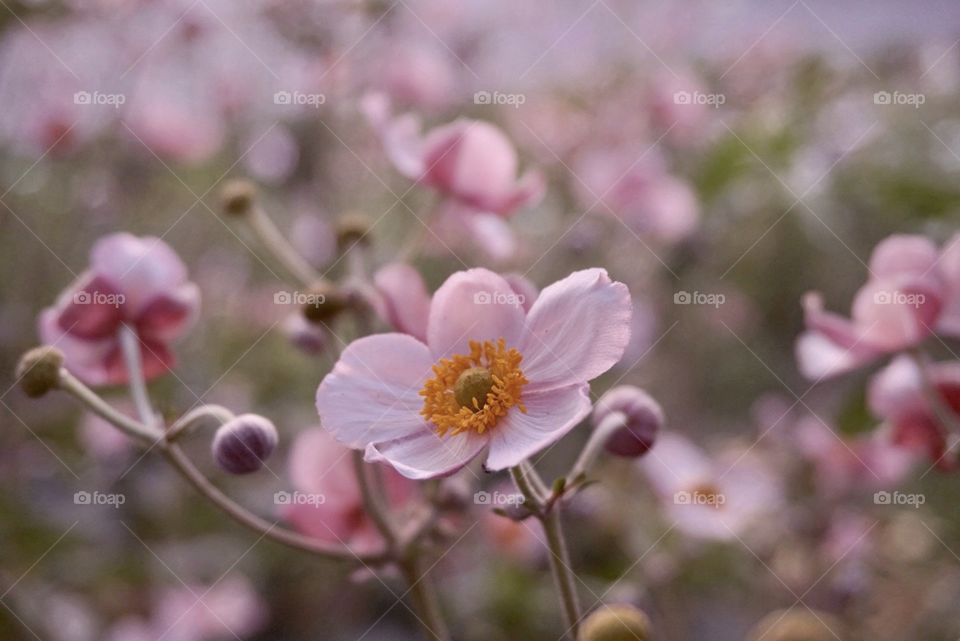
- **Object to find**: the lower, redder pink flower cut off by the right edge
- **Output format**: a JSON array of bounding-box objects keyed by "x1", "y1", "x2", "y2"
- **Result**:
[{"x1": 867, "y1": 356, "x2": 960, "y2": 470}]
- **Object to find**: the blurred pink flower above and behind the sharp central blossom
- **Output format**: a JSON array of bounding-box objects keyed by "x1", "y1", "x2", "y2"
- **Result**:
[{"x1": 363, "y1": 95, "x2": 545, "y2": 259}]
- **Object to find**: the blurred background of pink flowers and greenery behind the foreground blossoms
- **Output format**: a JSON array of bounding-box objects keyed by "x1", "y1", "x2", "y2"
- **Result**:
[{"x1": 0, "y1": 0, "x2": 960, "y2": 641}]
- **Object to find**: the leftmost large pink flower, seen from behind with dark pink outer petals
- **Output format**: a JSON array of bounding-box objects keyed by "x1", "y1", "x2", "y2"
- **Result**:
[{"x1": 40, "y1": 233, "x2": 200, "y2": 385}]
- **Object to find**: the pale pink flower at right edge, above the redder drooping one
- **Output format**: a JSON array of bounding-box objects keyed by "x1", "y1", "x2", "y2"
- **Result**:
[{"x1": 797, "y1": 235, "x2": 960, "y2": 379}]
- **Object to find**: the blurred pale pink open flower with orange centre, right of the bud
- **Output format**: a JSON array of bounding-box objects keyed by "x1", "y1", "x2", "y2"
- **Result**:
[{"x1": 640, "y1": 433, "x2": 783, "y2": 540}]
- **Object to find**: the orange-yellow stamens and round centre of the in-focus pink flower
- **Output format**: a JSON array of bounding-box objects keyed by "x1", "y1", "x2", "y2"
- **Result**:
[{"x1": 420, "y1": 338, "x2": 528, "y2": 436}]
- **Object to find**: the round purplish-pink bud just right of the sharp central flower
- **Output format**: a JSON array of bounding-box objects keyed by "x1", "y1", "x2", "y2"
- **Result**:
[{"x1": 593, "y1": 385, "x2": 665, "y2": 458}]
